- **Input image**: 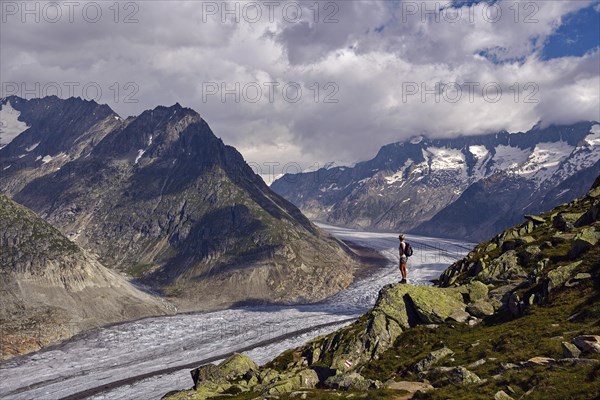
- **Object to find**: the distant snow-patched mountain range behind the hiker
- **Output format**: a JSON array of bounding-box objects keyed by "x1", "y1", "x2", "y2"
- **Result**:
[{"x1": 271, "y1": 122, "x2": 600, "y2": 240}]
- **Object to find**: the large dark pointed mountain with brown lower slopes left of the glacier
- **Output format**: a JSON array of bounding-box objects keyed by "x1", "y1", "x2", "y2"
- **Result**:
[{"x1": 0, "y1": 98, "x2": 358, "y2": 310}]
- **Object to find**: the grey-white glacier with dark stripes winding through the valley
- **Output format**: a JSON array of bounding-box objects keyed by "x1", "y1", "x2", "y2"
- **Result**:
[{"x1": 0, "y1": 226, "x2": 470, "y2": 399}]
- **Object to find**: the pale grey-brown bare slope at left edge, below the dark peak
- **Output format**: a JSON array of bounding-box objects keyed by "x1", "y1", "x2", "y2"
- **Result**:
[{"x1": 0, "y1": 194, "x2": 172, "y2": 359}]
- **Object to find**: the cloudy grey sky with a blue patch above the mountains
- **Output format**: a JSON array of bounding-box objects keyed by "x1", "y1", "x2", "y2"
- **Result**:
[{"x1": 0, "y1": 0, "x2": 600, "y2": 181}]
